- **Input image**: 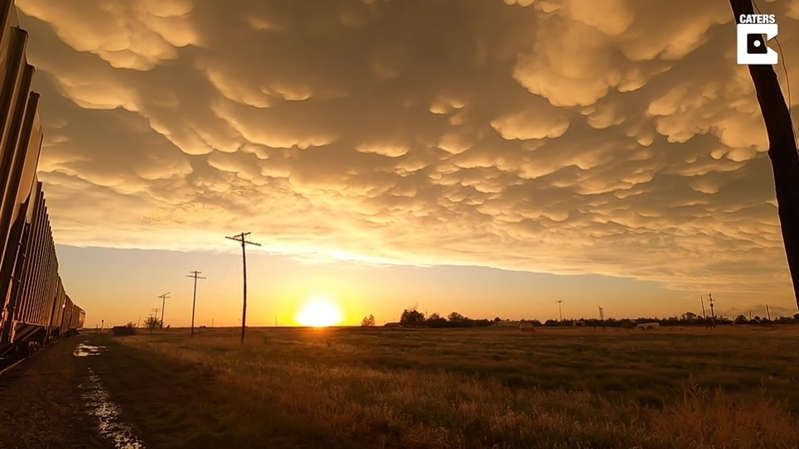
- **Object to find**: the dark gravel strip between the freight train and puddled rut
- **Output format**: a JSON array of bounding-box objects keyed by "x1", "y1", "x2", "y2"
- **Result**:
[{"x1": 0, "y1": 336, "x2": 113, "y2": 449}]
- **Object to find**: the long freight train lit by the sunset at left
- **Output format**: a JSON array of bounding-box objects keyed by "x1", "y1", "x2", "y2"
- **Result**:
[{"x1": 0, "y1": 0, "x2": 85, "y2": 356}]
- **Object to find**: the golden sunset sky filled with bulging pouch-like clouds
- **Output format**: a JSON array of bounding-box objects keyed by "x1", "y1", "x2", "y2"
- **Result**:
[{"x1": 10, "y1": 0, "x2": 799, "y2": 326}]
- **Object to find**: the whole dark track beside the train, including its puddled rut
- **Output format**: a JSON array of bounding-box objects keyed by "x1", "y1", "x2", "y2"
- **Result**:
[{"x1": 0, "y1": 333, "x2": 336, "y2": 449}]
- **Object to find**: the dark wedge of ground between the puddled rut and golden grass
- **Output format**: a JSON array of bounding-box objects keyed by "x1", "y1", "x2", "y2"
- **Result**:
[{"x1": 86, "y1": 336, "x2": 336, "y2": 449}]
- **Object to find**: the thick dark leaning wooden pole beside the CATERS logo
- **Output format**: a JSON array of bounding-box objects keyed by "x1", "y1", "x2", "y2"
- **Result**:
[{"x1": 730, "y1": 0, "x2": 799, "y2": 306}]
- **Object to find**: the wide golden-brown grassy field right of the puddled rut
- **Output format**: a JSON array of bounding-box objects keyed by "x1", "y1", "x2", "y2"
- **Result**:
[{"x1": 89, "y1": 326, "x2": 799, "y2": 448}]
